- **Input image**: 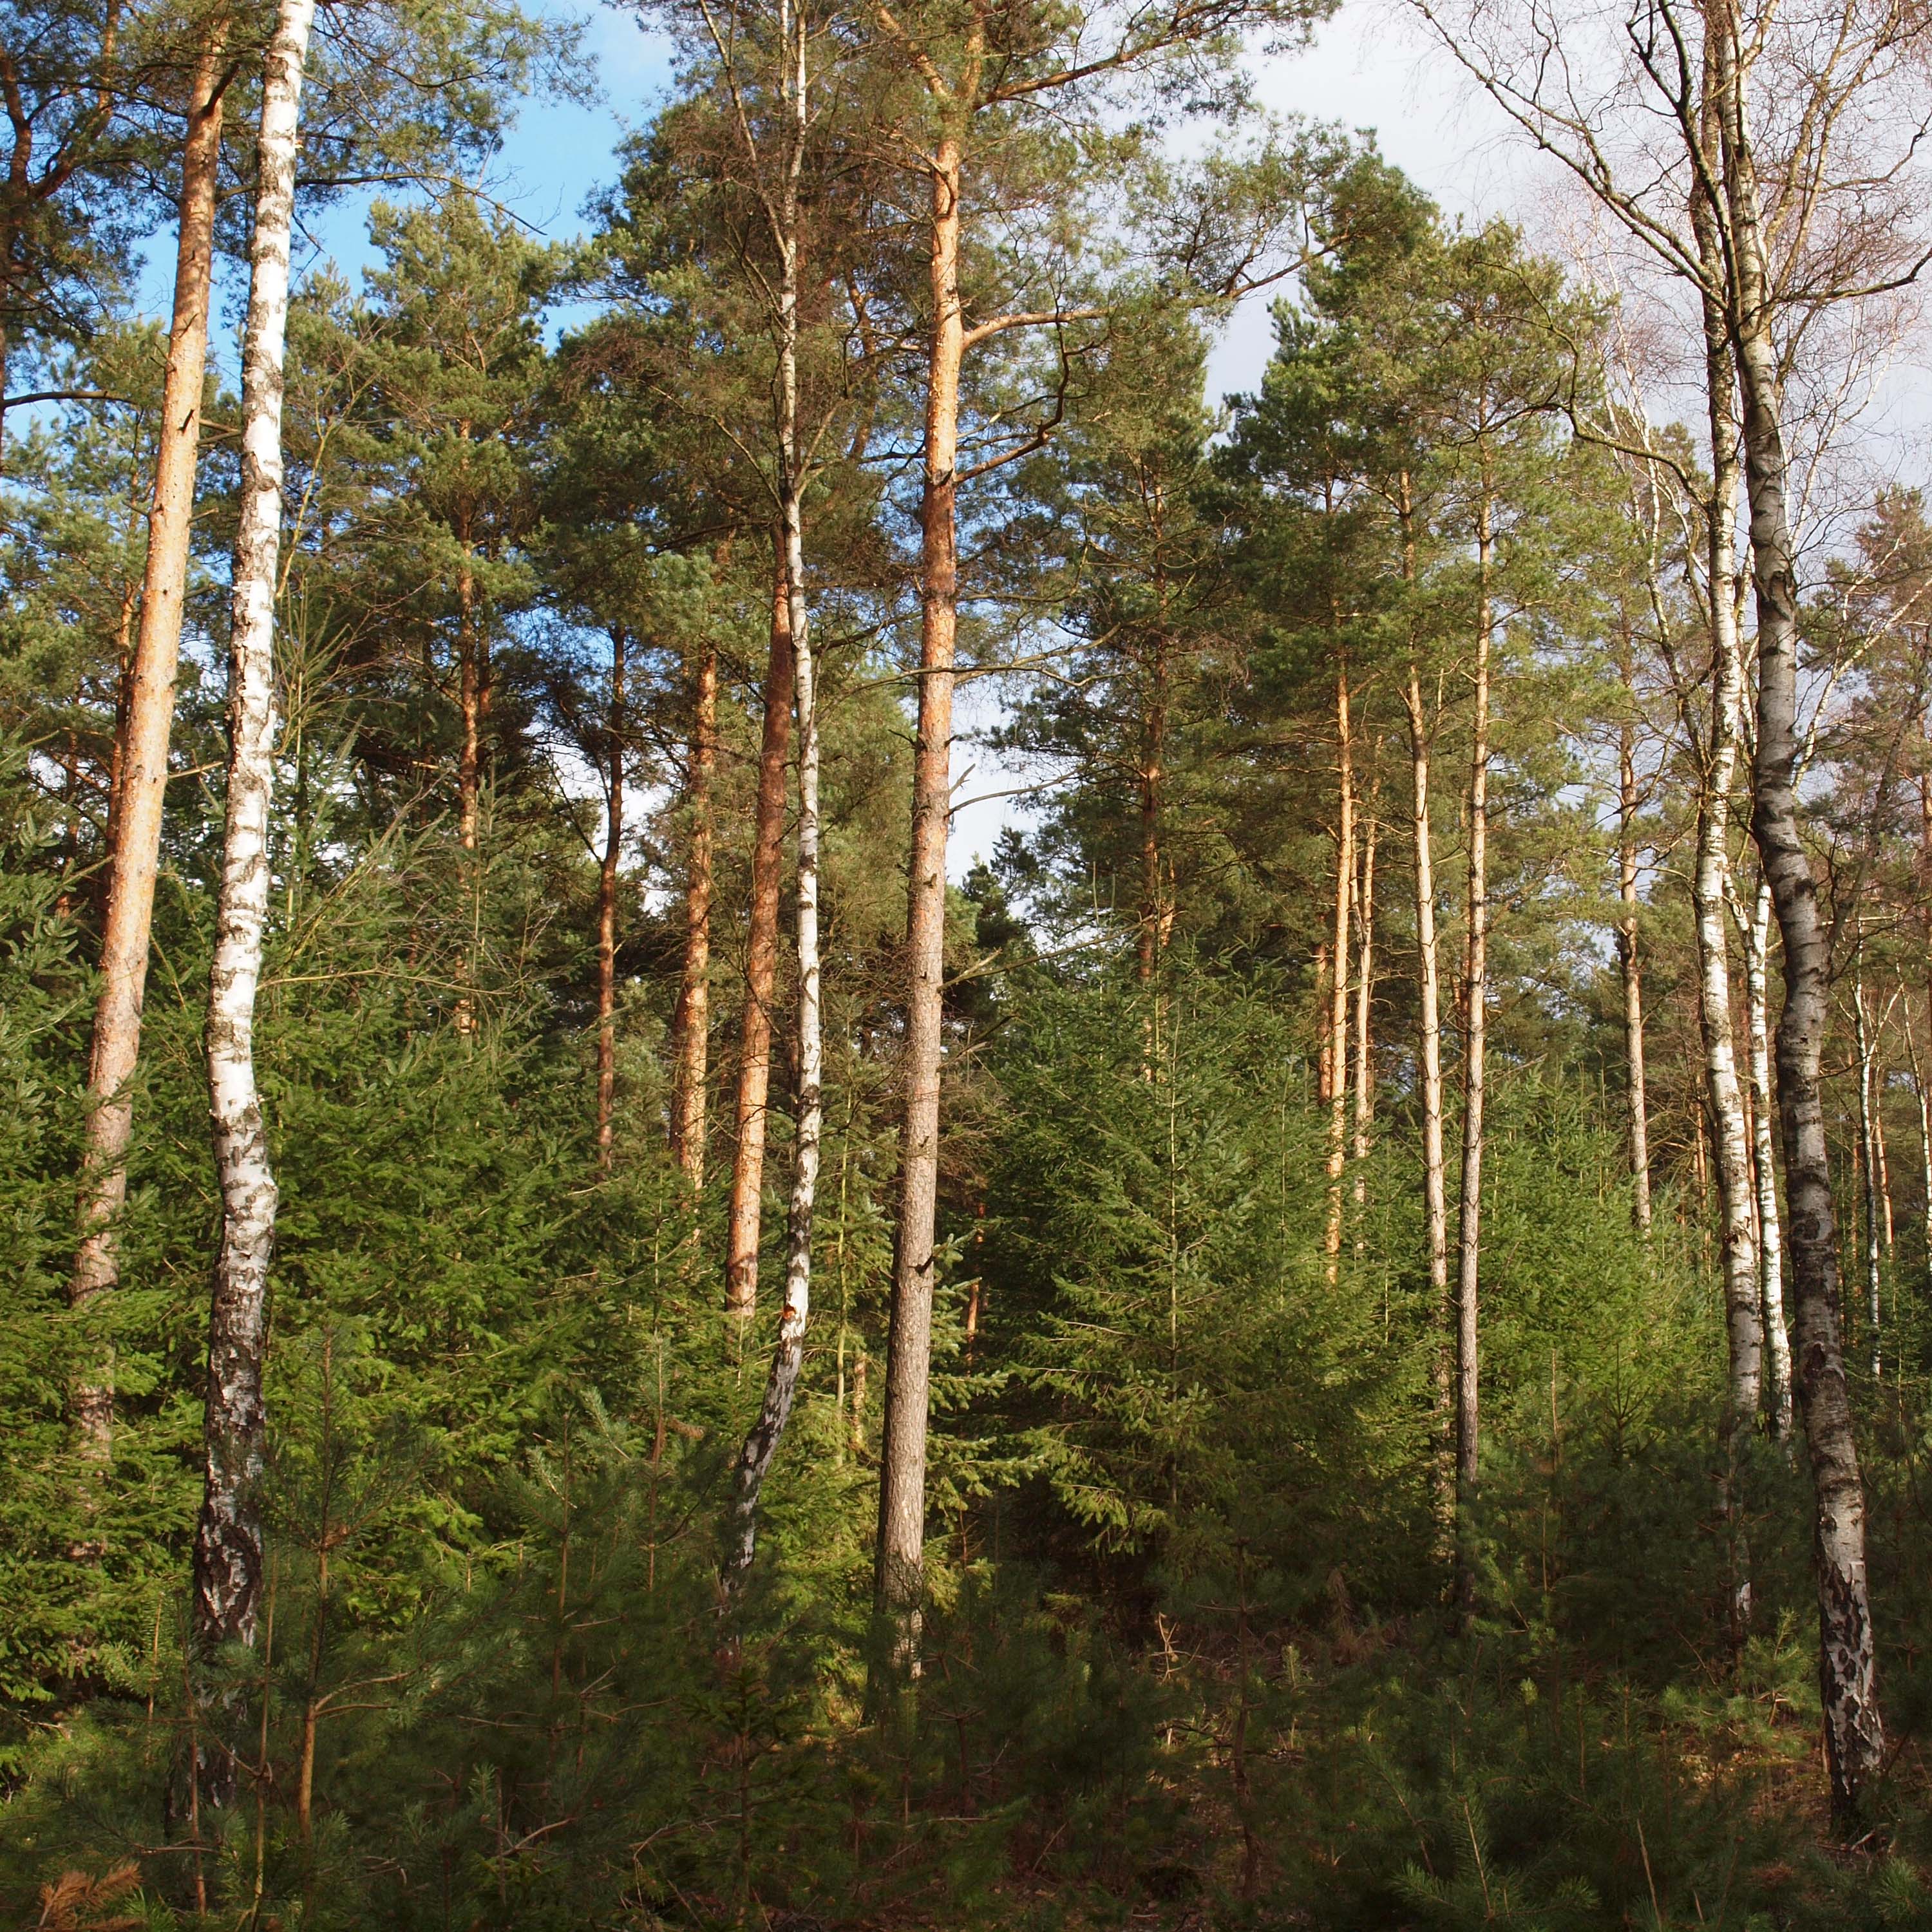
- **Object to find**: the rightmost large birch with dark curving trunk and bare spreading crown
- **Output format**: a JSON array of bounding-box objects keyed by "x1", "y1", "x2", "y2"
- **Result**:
[{"x1": 1418, "y1": 0, "x2": 1932, "y2": 1820}]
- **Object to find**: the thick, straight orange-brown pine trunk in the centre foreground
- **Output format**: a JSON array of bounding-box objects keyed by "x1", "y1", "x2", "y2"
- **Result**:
[{"x1": 875, "y1": 126, "x2": 966, "y2": 1671}]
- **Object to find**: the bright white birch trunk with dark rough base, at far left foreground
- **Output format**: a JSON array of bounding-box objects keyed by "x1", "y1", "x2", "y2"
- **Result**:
[{"x1": 193, "y1": 0, "x2": 315, "y2": 1754}]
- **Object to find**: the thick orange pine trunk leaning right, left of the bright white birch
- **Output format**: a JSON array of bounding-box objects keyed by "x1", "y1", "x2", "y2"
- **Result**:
[{"x1": 68, "y1": 19, "x2": 228, "y2": 1461}]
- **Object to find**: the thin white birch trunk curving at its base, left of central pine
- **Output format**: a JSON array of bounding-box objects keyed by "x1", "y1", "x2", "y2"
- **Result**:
[{"x1": 726, "y1": 0, "x2": 823, "y2": 1596}]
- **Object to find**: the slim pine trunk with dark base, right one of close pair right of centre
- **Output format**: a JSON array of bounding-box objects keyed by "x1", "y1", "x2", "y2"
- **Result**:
[{"x1": 1455, "y1": 491, "x2": 1495, "y2": 1623}]
